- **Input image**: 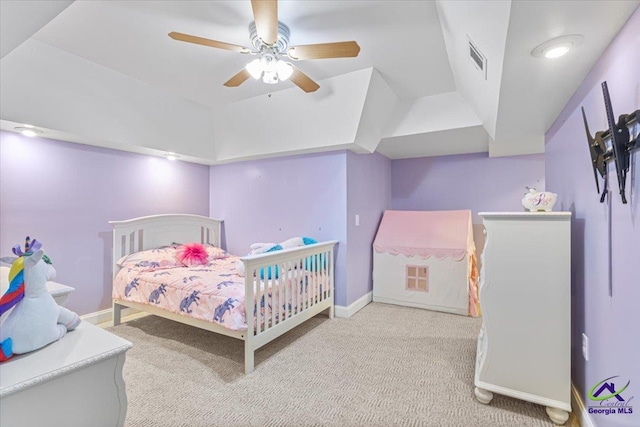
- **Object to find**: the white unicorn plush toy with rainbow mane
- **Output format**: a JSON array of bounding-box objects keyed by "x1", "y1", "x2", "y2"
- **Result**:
[{"x1": 0, "y1": 237, "x2": 80, "y2": 362}]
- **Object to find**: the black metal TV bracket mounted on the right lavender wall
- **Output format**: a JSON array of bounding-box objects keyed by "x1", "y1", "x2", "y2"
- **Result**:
[{"x1": 582, "y1": 82, "x2": 640, "y2": 203}]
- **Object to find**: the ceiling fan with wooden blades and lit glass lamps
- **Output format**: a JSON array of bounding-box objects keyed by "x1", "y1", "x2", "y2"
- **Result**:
[{"x1": 169, "y1": 0, "x2": 360, "y2": 92}]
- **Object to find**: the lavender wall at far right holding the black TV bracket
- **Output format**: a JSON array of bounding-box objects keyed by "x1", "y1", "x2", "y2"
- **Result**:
[{"x1": 546, "y1": 9, "x2": 640, "y2": 427}]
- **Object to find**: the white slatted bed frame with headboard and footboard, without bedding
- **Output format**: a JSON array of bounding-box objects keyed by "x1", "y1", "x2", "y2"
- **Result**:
[{"x1": 109, "y1": 214, "x2": 338, "y2": 374}]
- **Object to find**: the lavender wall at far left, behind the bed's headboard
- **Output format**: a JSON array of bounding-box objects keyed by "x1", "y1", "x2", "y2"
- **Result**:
[{"x1": 0, "y1": 132, "x2": 209, "y2": 315}]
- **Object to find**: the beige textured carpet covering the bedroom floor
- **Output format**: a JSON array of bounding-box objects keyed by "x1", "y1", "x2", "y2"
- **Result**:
[{"x1": 108, "y1": 303, "x2": 568, "y2": 427}]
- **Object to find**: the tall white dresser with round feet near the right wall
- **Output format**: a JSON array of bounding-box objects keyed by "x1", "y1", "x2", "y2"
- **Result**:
[{"x1": 475, "y1": 212, "x2": 571, "y2": 424}]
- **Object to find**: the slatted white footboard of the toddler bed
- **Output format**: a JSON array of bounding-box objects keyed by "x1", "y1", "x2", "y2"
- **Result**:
[{"x1": 241, "y1": 241, "x2": 338, "y2": 374}]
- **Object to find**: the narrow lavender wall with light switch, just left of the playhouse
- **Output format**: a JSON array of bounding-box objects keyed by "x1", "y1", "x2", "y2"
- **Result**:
[{"x1": 346, "y1": 152, "x2": 391, "y2": 305}]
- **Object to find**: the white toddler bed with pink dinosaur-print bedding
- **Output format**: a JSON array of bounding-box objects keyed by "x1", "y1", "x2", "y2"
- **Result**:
[{"x1": 110, "y1": 214, "x2": 337, "y2": 373}]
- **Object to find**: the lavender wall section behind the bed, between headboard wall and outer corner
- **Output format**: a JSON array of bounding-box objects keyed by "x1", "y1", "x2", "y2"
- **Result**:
[{"x1": 209, "y1": 151, "x2": 347, "y2": 305}]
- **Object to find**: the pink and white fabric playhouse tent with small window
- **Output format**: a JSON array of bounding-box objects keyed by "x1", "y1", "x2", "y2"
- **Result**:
[{"x1": 373, "y1": 210, "x2": 480, "y2": 316}]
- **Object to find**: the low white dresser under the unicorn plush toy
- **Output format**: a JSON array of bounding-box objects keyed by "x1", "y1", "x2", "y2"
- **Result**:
[{"x1": 0, "y1": 321, "x2": 131, "y2": 427}]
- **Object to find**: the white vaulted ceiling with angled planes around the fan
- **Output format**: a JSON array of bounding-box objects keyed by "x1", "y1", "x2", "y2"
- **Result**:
[{"x1": 0, "y1": 0, "x2": 639, "y2": 164}]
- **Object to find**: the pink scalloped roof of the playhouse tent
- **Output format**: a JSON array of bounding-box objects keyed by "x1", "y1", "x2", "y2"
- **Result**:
[{"x1": 373, "y1": 210, "x2": 475, "y2": 260}]
